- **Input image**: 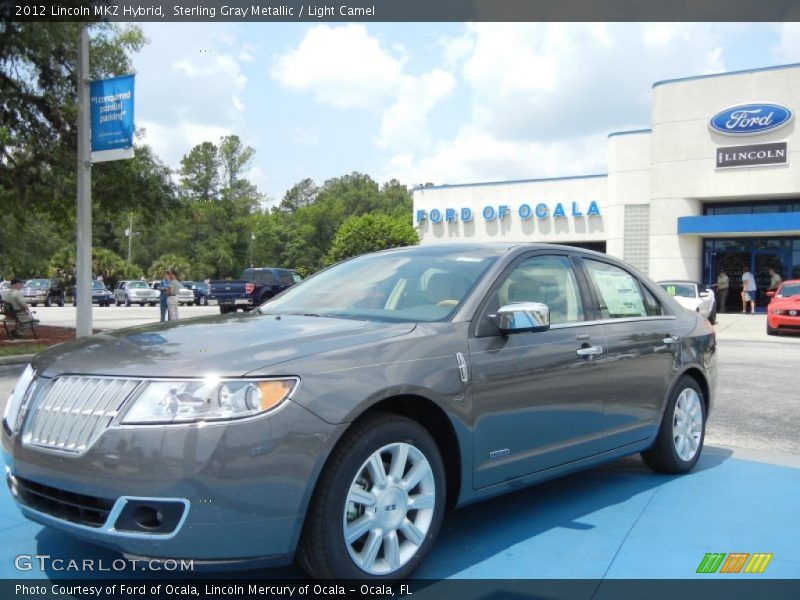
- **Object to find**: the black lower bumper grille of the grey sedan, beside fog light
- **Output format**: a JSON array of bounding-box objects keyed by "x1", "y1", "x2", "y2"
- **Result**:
[{"x1": 11, "y1": 476, "x2": 114, "y2": 527}]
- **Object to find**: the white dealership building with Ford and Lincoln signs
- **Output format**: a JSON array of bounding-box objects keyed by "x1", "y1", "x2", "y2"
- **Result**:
[{"x1": 414, "y1": 64, "x2": 800, "y2": 307}]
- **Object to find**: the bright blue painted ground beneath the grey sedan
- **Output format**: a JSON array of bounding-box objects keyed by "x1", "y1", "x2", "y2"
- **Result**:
[{"x1": 0, "y1": 447, "x2": 800, "y2": 579}]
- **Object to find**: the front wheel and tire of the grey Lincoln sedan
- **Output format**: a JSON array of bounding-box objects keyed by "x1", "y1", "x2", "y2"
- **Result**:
[{"x1": 297, "y1": 413, "x2": 445, "y2": 580}]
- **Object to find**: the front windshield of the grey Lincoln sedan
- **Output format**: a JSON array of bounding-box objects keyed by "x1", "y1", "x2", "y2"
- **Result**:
[{"x1": 260, "y1": 247, "x2": 497, "y2": 322}]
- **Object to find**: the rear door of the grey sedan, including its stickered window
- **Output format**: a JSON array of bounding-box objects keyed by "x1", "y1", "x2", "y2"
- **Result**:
[{"x1": 580, "y1": 258, "x2": 680, "y2": 451}]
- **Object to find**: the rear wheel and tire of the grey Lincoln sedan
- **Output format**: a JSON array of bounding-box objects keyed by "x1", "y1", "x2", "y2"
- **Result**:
[{"x1": 642, "y1": 375, "x2": 706, "y2": 474}]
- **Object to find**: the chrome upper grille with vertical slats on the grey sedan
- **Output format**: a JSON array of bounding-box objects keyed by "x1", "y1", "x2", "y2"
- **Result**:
[{"x1": 22, "y1": 376, "x2": 141, "y2": 454}]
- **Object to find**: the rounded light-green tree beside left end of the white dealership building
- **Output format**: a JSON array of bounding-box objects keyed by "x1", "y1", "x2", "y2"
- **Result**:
[{"x1": 325, "y1": 214, "x2": 419, "y2": 264}]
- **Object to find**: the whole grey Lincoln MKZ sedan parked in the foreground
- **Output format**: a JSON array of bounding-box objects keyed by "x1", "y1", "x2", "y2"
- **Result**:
[{"x1": 2, "y1": 243, "x2": 716, "y2": 579}]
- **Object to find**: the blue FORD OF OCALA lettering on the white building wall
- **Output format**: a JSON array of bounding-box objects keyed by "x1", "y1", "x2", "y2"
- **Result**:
[{"x1": 415, "y1": 200, "x2": 600, "y2": 223}]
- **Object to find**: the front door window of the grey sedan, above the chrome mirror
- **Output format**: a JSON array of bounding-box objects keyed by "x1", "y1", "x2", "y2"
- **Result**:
[{"x1": 497, "y1": 256, "x2": 584, "y2": 325}]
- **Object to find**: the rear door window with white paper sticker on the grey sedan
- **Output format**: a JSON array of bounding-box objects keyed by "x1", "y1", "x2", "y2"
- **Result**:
[{"x1": 583, "y1": 259, "x2": 647, "y2": 319}]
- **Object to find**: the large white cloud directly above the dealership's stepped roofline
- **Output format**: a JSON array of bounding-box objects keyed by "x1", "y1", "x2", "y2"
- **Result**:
[{"x1": 384, "y1": 23, "x2": 734, "y2": 188}]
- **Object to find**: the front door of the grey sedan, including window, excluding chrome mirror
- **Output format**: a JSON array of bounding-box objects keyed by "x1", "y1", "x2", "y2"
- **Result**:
[{"x1": 469, "y1": 254, "x2": 605, "y2": 488}]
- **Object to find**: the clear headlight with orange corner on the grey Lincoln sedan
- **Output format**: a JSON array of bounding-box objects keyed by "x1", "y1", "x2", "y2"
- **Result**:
[{"x1": 122, "y1": 377, "x2": 300, "y2": 425}]
